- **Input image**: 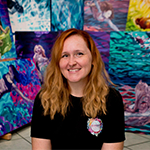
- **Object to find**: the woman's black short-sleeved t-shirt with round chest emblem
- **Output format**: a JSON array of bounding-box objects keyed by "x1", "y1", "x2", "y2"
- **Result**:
[{"x1": 31, "y1": 88, "x2": 125, "y2": 150}]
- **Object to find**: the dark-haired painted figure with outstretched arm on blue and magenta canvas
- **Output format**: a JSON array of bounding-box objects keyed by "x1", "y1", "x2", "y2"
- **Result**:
[{"x1": 0, "y1": 65, "x2": 33, "y2": 103}]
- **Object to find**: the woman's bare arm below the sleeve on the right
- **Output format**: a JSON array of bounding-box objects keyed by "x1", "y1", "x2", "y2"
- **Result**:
[{"x1": 101, "y1": 141, "x2": 124, "y2": 150}]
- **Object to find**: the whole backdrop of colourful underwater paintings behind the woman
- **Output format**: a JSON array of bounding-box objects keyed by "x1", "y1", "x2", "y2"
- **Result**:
[{"x1": 0, "y1": 0, "x2": 150, "y2": 136}]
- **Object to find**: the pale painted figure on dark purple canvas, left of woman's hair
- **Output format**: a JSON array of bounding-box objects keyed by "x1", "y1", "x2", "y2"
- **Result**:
[{"x1": 33, "y1": 45, "x2": 49, "y2": 82}]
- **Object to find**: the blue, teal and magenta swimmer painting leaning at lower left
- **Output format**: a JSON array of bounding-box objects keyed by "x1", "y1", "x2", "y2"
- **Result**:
[{"x1": 0, "y1": 58, "x2": 41, "y2": 136}]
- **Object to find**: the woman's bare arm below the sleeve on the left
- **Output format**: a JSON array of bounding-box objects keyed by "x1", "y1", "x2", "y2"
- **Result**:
[{"x1": 31, "y1": 137, "x2": 52, "y2": 150}]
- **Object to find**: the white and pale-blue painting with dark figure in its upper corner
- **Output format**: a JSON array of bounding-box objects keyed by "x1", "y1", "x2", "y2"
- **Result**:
[{"x1": 7, "y1": 0, "x2": 51, "y2": 33}]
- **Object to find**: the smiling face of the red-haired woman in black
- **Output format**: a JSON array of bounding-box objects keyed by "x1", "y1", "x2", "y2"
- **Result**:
[{"x1": 59, "y1": 35, "x2": 92, "y2": 84}]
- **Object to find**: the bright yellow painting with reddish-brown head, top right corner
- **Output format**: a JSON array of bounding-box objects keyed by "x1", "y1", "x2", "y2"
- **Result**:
[{"x1": 126, "y1": 0, "x2": 150, "y2": 31}]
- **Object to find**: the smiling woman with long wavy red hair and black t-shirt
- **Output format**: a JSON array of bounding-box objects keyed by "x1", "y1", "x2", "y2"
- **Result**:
[{"x1": 31, "y1": 29, "x2": 125, "y2": 150}]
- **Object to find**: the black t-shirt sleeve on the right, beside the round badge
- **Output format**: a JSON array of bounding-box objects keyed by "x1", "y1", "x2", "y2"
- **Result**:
[{"x1": 103, "y1": 88, "x2": 125, "y2": 143}]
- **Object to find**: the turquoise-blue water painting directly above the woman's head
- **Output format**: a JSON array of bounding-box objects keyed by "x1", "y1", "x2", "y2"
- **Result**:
[{"x1": 51, "y1": 0, "x2": 84, "y2": 31}]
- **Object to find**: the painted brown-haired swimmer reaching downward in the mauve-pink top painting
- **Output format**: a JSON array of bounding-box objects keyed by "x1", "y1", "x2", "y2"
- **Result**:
[{"x1": 87, "y1": 0, "x2": 119, "y2": 31}]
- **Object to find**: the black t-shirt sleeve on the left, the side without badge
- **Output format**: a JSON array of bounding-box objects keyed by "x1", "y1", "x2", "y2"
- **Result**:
[{"x1": 31, "y1": 93, "x2": 51, "y2": 139}]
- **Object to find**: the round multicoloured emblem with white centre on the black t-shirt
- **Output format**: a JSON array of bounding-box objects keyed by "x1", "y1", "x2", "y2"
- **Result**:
[{"x1": 87, "y1": 118, "x2": 103, "y2": 136}]
